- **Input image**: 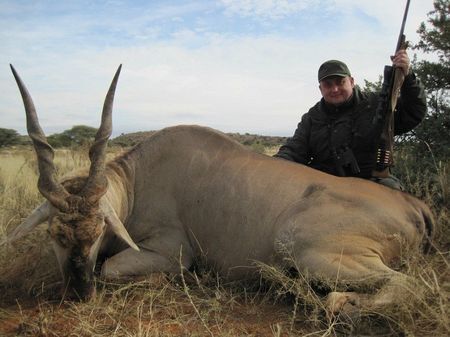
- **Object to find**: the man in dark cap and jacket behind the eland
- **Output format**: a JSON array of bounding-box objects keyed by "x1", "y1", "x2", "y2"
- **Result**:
[{"x1": 275, "y1": 50, "x2": 427, "y2": 189}]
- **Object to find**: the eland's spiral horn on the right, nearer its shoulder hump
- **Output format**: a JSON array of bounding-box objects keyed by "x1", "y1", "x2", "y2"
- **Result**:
[{"x1": 80, "y1": 65, "x2": 122, "y2": 203}]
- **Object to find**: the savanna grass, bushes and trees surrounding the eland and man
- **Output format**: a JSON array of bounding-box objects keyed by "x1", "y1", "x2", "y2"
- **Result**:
[{"x1": 0, "y1": 0, "x2": 450, "y2": 337}]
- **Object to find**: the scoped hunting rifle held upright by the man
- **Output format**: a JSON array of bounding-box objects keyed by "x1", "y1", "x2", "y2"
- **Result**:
[{"x1": 372, "y1": 0, "x2": 410, "y2": 178}]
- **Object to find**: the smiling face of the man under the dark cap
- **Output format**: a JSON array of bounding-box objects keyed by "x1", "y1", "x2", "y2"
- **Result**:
[{"x1": 319, "y1": 76, "x2": 355, "y2": 105}]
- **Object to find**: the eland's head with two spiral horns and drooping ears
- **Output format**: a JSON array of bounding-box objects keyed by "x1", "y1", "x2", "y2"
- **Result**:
[{"x1": 5, "y1": 65, "x2": 139, "y2": 299}]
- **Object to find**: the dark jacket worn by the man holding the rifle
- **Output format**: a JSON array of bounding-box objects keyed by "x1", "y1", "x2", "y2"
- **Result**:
[{"x1": 275, "y1": 73, "x2": 427, "y2": 178}]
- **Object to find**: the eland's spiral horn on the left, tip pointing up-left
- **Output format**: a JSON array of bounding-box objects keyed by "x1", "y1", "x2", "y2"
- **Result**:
[{"x1": 10, "y1": 64, "x2": 70, "y2": 211}]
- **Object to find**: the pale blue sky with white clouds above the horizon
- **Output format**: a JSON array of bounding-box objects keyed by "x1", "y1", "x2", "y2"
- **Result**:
[{"x1": 0, "y1": 0, "x2": 433, "y2": 136}]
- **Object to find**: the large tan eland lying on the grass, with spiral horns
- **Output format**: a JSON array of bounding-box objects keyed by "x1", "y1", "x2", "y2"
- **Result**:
[{"x1": 4, "y1": 66, "x2": 433, "y2": 312}]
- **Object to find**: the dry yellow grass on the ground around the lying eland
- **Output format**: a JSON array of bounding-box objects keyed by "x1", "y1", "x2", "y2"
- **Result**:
[{"x1": 0, "y1": 149, "x2": 450, "y2": 337}]
